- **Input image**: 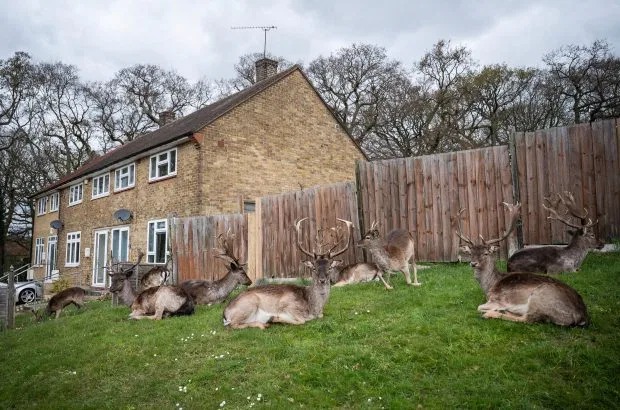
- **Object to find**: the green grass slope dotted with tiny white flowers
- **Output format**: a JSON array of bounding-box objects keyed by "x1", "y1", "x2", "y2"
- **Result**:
[{"x1": 0, "y1": 253, "x2": 620, "y2": 409}]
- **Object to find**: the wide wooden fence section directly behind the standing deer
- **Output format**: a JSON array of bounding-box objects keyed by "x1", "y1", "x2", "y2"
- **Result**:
[{"x1": 357, "y1": 146, "x2": 513, "y2": 261}]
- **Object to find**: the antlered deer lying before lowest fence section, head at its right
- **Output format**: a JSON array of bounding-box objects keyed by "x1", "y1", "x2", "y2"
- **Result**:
[{"x1": 179, "y1": 233, "x2": 252, "y2": 305}]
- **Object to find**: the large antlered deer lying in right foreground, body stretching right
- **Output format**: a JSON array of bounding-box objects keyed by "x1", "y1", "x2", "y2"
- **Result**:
[{"x1": 456, "y1": 202, "x2": 588, "y2": 326}]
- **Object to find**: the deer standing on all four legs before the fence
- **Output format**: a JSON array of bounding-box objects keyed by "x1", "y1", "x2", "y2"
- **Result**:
[{"x1": 357, "y1": 222, "x2": 421, "y2": 289}]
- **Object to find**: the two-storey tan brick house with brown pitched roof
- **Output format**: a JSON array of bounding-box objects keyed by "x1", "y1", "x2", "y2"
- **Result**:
[{"x1": 32, "y1": 59, "x2": 365, "y2": 287}]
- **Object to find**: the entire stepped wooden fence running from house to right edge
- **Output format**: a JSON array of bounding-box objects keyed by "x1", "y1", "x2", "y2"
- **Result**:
[{"x1": 171, "y1": 120, "x2": 620, "y2": 280}]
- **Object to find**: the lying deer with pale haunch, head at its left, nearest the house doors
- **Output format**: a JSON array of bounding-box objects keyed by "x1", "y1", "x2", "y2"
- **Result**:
[{"x1": 108, "y1": 252, "x2": 194, "y2": 320}]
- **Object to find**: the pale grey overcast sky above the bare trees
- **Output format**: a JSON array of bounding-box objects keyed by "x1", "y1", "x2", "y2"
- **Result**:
[{"x1": 0, "y1": 0, "x2": 620, "y2": 81}]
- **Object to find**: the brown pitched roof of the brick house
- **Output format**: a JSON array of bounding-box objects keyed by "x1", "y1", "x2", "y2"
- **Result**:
[{"x1": 33, "y1": 65, "x2": 365, "y2": 198}]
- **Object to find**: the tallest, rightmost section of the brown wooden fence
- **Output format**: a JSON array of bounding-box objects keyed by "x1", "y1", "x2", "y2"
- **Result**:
[{"x1": 514, "y1": 119, "x2": 620, "y2": 245}]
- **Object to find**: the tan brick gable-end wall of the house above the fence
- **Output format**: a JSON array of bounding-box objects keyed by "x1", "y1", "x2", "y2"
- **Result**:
[{"x1": 202, "y1": 71, "x2": 363, "y2": 215}]
